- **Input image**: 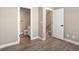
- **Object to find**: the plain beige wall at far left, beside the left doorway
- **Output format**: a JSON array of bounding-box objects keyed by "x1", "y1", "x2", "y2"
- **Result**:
[{"x1": 0, "y1": 7, "x2": 18, "y2": 45}]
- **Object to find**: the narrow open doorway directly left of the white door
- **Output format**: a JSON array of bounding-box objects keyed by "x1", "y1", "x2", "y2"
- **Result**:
[{"x1": 46, "y1": 9, "x2": 53, "y2": 39}]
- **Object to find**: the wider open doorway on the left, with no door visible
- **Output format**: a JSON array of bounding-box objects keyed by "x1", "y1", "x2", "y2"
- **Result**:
[{"x1": 20, "y1": 7, "x2": 31, "y2": 43}]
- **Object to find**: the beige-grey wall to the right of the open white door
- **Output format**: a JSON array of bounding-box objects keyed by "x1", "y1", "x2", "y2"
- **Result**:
[{"x1": 64, "y1": 7, "x2": 79, "y2": 43}]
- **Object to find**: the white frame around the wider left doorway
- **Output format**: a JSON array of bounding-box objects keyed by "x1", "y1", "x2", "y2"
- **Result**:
[{"x1": 17, "y1": 7, "x2": 32, "y2": 43}]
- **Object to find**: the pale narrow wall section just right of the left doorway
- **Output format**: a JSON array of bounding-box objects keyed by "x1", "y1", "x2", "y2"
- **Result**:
[{"x1": 31, "y1": 7, "x2": 39, "y2": 38}]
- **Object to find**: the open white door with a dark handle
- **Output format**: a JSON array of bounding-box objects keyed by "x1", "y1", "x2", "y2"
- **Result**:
[{"x1": 53, "y1": 8, "x2": 64, "y2": 39}]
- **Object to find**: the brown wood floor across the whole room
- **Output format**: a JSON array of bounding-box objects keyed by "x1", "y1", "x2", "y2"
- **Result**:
[{"x1": 1, "y1": 37, "x2": 79, "y2": 51}]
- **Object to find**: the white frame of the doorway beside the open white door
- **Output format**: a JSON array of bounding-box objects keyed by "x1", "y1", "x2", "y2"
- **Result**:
[{"x1": 43, "y1": 7, "x2": 53, "y2": 40}]
